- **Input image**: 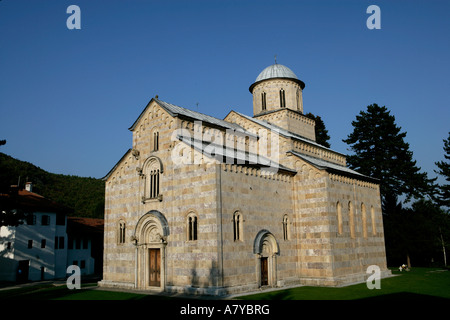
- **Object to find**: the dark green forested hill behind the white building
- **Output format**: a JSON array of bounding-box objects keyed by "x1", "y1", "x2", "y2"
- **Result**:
[{"x1": 0, "y1": 152, "x2": 105, "y2": 219}]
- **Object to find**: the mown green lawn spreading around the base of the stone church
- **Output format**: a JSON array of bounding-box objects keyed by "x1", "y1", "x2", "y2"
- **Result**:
[{"x1": 0, "y1": 268, "x2": 450, "y2": 300}]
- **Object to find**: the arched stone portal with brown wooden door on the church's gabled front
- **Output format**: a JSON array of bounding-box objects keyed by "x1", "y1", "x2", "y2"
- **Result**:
[{"x1": 134, "y1": 210, "x2": 169, "y2": 291}]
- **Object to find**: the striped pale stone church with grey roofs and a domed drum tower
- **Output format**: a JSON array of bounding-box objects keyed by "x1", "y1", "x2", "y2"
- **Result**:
[{"x1": 100, "y1": 64, "x2": 389, "y2": 296}]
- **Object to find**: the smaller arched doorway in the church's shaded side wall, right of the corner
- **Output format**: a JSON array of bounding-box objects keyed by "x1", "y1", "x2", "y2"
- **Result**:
[{"x1": 253, "y1": 230, "x2": 280, "y2": 287}]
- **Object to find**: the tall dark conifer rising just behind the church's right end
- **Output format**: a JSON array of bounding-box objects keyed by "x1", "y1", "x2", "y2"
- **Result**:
[{"x1": 342, "y1": 104, "x2": 435, "y2": 201}]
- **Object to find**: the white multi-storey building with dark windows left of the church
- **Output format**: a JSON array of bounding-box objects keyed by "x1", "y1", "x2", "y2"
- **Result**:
[{"x1": 0, "y1": 188, "x2": 103, "y2": 282}]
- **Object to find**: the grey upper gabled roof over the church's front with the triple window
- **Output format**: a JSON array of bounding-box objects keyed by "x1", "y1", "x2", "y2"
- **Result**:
[{"x1": 129, "y1": 98, "x2": 254, "y2": 136}]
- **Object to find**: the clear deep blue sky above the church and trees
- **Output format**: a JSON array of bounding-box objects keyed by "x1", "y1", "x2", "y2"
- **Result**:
[{"x1": 0, "y1": 0, "x2": 450, "y2": 182}]
